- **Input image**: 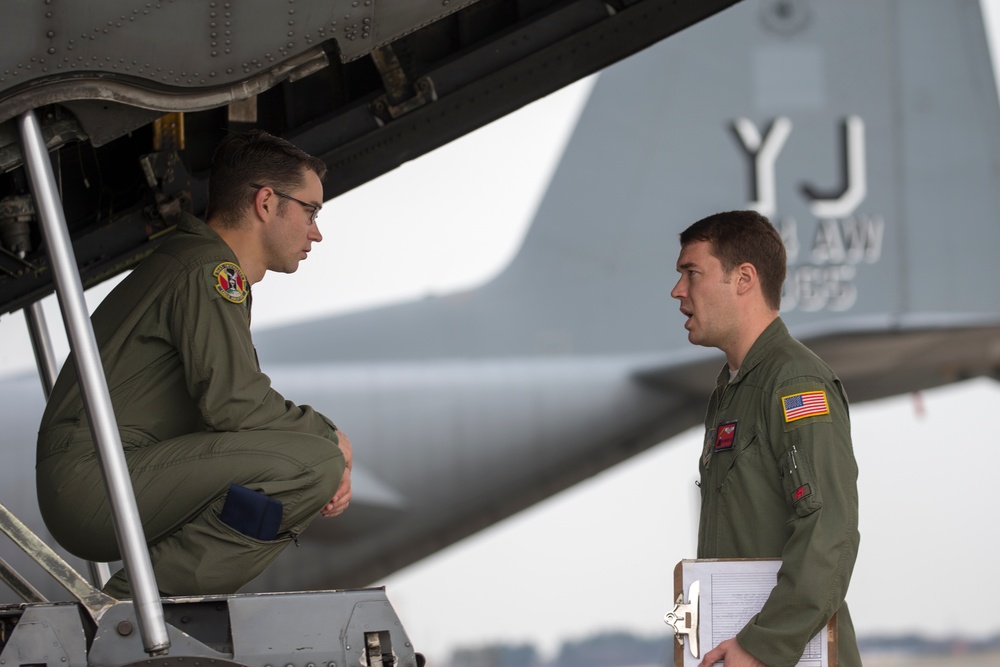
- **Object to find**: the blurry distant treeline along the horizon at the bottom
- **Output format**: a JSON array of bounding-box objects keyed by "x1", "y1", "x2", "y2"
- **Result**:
[{"x1": 442, "y1": 632, "x2": 1000, "y2": 667}]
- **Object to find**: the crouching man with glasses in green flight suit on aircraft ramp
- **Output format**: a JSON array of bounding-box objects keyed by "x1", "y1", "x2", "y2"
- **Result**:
[{"x1": 36, "y1": 131, "x2": 351, "y2": 598}]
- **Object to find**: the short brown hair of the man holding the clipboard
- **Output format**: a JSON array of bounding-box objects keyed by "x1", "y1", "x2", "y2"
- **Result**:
[{"x1": 681, "y1": 211, "x2": 788, "y2": 310}]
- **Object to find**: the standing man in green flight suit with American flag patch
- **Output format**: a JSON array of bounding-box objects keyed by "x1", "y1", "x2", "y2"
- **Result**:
[{"x1": 671, "y1": 211, "x2": 861, "y2": 667}]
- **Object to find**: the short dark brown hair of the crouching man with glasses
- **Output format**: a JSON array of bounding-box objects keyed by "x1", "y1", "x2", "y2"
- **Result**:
[{"x1": 205, "y1": 130, "x2": 326, "y2": 227}]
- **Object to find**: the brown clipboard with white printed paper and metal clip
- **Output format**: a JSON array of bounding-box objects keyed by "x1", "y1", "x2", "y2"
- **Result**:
[{"x1": 663, "y1": 558, "x2": 837, "y2": 667}]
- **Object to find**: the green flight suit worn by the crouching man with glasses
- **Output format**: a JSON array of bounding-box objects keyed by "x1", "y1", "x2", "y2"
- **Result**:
[{"x1": 36, "y1": 216, "x2": 344, "y2": 597}]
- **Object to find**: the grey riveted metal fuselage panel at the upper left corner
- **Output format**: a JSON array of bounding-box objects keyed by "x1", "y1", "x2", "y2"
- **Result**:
[{"x1": 0, "y1": 0, "x2": 486, "y2": 120}]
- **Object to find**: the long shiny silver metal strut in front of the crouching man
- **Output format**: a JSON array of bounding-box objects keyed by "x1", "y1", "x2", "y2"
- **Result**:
[{"x1": 17, "y1": 111, "x2": 170, "y2": 654}]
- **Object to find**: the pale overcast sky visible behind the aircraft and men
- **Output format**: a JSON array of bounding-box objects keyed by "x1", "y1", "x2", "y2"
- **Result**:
[{"x1": 0, "y1": 0, "x2": 1000, "y2": 662}]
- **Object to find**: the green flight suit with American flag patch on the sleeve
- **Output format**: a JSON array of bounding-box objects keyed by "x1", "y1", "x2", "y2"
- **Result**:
[{"x1": 698, "y1": 318, "x2": 861, "y2": 667}]
